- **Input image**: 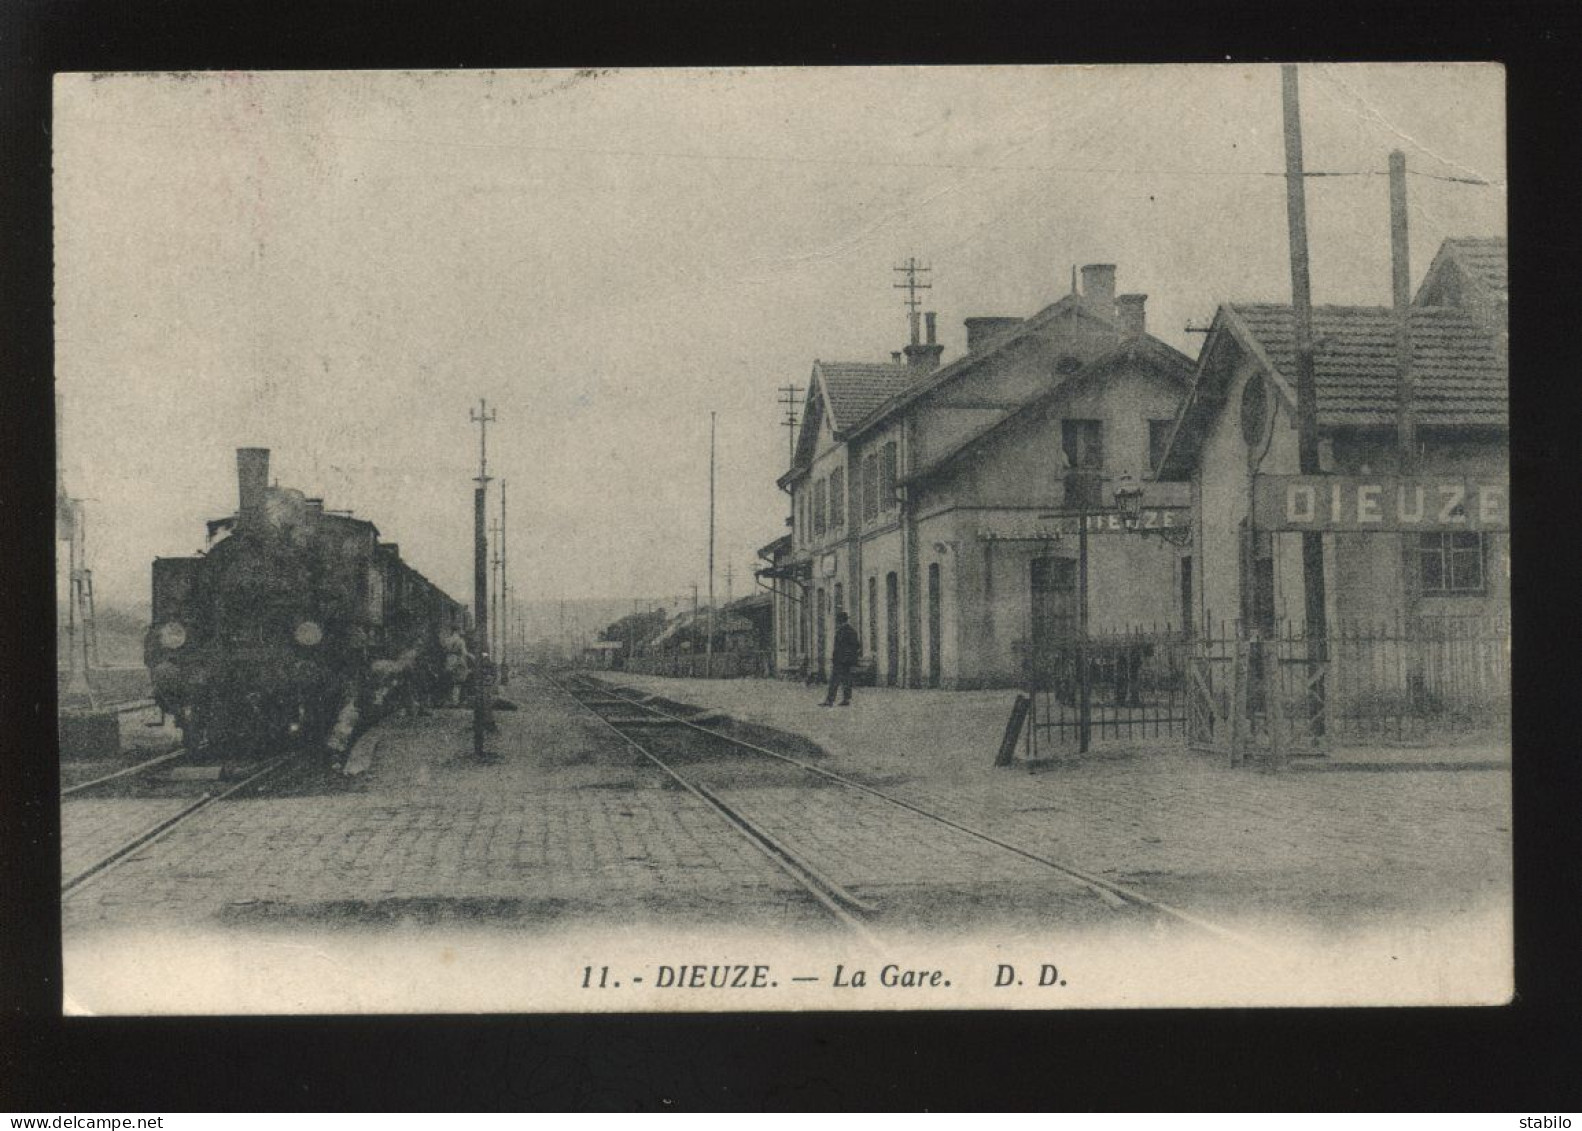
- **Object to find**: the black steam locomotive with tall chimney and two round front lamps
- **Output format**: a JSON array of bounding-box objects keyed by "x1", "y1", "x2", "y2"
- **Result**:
[{"x1": 144, "y1": 448, "x2": 468, "y2": 759}]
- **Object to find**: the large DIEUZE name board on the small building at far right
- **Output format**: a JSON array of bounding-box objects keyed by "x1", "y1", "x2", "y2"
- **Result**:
[{"x1": 1253, "y1": 475, "x2": 1511, "y2": 533}]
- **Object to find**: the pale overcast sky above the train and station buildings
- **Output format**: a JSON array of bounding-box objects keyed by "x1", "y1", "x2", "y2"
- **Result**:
[{"x1": 54, "y1": 65, "x2": 1506, "y2": 613}]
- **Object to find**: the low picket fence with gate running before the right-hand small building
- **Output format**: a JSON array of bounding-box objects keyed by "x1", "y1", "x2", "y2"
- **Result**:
[{"x1": 1027, "y1": 617, "x2": 1511, "y2": 759}]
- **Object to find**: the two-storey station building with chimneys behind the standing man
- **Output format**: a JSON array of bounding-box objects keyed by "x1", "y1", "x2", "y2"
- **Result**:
[{"x1": 759, "y1": 264, "x2": 1196, "y2": 688}]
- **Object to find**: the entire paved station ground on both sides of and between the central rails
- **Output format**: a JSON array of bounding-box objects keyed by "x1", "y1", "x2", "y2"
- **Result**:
[{"x1": 65, "y1": 667, "x2": 1509, "y2": 932}]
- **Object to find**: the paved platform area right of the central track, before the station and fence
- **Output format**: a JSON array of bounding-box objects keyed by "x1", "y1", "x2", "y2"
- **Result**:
[{"x1": 612, "y1": 674, "x2": 1511, "y2": 929}]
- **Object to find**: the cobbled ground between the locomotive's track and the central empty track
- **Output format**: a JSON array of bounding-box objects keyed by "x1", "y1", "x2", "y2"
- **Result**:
[{"x1": 65, "y1": 693, "x2": 812, "y2": 932}]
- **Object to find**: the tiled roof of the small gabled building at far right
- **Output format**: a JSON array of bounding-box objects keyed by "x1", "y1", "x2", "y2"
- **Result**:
[{"x1": 1231, "y1": 303, "x2": 1509, "y2": 426}]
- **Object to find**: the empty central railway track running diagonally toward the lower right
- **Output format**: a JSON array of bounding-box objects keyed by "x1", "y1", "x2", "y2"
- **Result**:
[{"x1": 546, "y1": 675, "x2": 1266, "y2": 951}]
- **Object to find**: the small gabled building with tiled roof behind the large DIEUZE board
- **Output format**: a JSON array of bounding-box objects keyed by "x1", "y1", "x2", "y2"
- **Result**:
[{"x1": 1160, "y1": 239, "x2": 1511, "y2": 637}]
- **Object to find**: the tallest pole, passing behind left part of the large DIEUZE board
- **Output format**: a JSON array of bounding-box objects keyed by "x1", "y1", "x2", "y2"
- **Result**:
[{"x1": 1269, "y1": 63, "x2": 1329, "y2": 752}]
